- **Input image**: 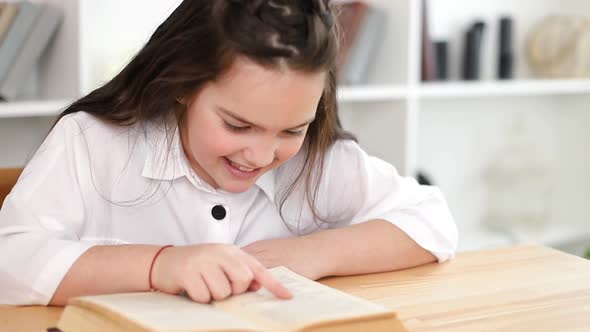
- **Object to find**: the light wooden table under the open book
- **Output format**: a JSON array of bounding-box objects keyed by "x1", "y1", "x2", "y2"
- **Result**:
[{"x1": 0, "y1": 246, "x2": 590, "y2": 332}]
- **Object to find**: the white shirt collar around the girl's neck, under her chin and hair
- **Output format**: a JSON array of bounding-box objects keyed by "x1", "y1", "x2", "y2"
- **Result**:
[{"x1": 141, "y1": 120, "x2": 276, "y2": 202}]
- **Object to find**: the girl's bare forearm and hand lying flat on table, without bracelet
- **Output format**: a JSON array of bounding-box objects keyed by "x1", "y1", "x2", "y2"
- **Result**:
[{"x1": 243, "y1": 220, "x2": 436, "y2": 279}]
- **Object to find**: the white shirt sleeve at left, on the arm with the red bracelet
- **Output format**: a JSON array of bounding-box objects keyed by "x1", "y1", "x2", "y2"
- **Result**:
[{"x1": 0, "y1": 116, "x2": 91, "y2": 305}]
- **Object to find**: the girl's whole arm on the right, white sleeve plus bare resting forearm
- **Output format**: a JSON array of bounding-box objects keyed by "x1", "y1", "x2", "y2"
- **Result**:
[{"x1": 254, "y1": 140, "x2": 457, "y2": 279}]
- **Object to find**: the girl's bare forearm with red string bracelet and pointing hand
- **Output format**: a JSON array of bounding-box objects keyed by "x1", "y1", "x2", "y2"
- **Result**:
[{"x1": 49, "y1": 244, "x2": 291, "y2": 305}]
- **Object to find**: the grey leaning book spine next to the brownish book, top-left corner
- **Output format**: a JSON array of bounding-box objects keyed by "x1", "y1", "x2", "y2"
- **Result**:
[{"x1": 0, "y1": 1, "x2": 41, "y2": 86}]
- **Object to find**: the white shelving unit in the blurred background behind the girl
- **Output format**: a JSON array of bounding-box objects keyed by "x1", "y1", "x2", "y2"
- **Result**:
[{"x1": 0, "y1": 0, "x2": 590, "y2": 254}]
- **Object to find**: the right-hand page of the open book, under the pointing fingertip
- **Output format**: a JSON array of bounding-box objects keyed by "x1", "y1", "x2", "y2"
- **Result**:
[{"x1": 214, "y1": 267, "x2": 394, "y2": 329}]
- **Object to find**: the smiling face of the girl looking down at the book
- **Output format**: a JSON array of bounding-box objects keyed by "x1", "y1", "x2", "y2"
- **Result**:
[{"x1": 180, "y1": 59, "x2": 326, "y2": 193}]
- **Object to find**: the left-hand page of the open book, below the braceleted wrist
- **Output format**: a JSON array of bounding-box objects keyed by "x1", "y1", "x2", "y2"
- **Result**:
[{"x1": 73, "y1": 292, "x2": 259, "y2": 332}]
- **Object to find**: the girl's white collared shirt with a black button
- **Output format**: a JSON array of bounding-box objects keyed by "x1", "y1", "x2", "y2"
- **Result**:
[{"x1": 0, "y1": 112, "x2": 457, "y2": 304}]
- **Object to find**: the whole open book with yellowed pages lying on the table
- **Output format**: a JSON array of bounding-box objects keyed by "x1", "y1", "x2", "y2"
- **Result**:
[{"x1": 58, "y1": 267, "x2": 406, "y2": 332}]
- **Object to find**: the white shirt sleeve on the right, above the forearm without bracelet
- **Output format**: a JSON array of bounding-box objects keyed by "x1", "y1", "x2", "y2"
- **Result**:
[{"x1": 302, "y1": 140, "x2": 458, "y2": 262}]
